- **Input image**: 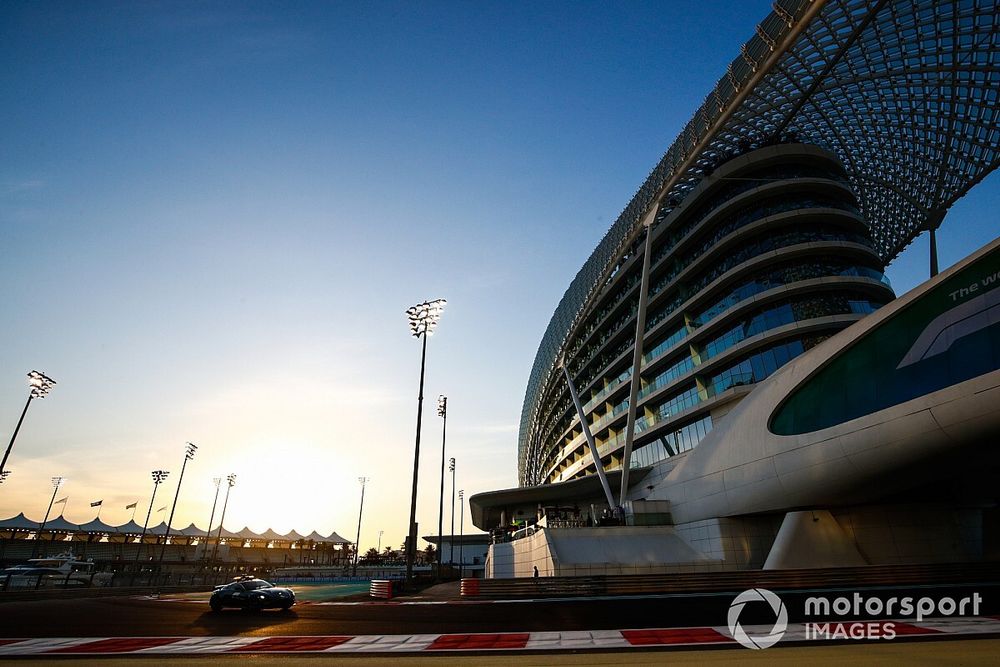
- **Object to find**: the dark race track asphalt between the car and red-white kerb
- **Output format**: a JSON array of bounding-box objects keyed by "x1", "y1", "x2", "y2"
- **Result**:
[{"x1": 0, "y1": 584, "x2": 1000, "y2": 638}]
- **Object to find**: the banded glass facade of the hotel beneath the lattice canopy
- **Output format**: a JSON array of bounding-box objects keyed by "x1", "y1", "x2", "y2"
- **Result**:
[{"x1": 529, "y1": 149, "x2": 893, "y2": 483}]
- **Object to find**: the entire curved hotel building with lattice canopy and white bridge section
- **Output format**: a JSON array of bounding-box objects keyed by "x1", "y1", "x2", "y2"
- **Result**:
[{"x1": 470, "y1": 0, "x2": 1000, "y2": 577}]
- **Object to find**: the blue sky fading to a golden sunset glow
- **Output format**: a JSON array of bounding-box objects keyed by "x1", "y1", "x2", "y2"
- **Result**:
[{"x1": 0, "y1": 0, "x2": 1000, "y2": 550}]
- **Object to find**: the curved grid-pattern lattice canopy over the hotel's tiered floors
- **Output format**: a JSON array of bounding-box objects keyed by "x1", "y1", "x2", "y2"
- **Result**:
[{"x1": 518, "y1": 0, "x2": 1000, "y2": 485}]
